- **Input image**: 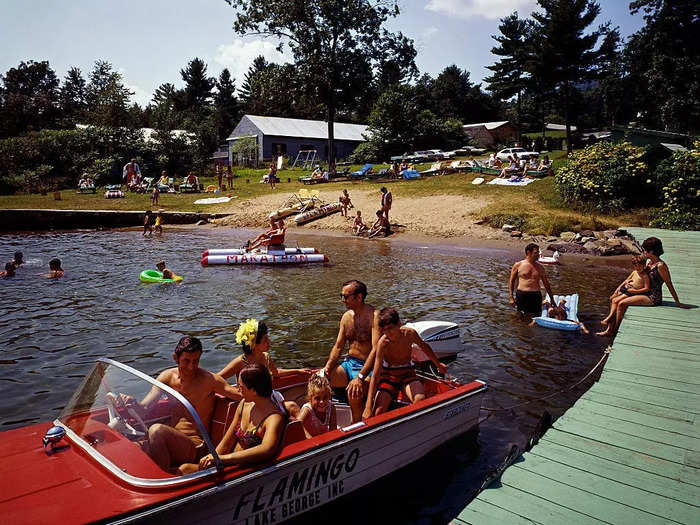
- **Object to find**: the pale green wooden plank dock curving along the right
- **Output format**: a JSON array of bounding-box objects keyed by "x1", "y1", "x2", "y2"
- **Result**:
[{"x1": 453, "y1": 228, "x2": 700, "y2": 525}]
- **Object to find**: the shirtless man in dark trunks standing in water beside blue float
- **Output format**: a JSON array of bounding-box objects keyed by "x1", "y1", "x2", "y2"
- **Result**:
[{"x1": 508, "y1": 243, "x2": 555, "y2": 315}]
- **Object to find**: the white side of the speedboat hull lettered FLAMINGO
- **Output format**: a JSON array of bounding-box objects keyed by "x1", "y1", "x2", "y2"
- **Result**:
[{"x1": 117, "y1": 383, "x2": 485, "y2": 525}]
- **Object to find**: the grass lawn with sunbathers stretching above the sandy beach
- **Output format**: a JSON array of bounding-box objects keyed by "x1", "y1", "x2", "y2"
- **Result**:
[{"x1": 0, "y1": 151, "x2": 649, "y2": 235}]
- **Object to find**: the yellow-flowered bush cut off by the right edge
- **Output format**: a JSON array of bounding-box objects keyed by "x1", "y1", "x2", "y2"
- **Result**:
[{"x1": 651, "y1": 141, "x2": 700, "y2": 230}]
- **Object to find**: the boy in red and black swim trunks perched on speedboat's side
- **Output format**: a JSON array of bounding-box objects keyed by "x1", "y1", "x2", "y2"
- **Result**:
[{"x1": 363, "y1": 307, "x2": 447, "y2": 417}]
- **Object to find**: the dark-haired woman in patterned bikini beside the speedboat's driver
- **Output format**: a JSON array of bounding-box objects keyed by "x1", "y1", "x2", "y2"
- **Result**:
[{"x1": 185, "y1": 364, "x2": 289, "y2": 474}]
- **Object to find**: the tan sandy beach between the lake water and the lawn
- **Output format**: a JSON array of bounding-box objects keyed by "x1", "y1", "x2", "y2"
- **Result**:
[{"x1": 214, "y1": 185, "x2": 509, "y2": 239}]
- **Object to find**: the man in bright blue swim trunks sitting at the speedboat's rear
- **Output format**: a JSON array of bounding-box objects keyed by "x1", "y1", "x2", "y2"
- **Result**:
[{"x1": 321, "y1": 279, "x2": 378, "y2": 423}]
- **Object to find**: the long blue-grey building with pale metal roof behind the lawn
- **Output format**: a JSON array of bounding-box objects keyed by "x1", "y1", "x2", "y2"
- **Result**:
[{"x1": 226, "y1": 115, "x2": 367, "y2": 163}]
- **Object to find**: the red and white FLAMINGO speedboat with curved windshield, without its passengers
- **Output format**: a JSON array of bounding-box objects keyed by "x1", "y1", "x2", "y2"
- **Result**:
[{"x1": 0, "y1": 359, "x2": 486, "y2": 525}]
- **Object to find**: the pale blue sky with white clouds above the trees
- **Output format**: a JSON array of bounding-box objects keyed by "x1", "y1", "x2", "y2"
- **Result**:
[{"x1": 0, "y1": 0, "x2": 643, "y2": 105}]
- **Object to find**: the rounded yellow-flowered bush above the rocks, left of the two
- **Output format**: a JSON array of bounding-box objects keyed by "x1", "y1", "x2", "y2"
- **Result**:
[{"x1": 555, "y1": 142, "x2": 653, "y2": 212}]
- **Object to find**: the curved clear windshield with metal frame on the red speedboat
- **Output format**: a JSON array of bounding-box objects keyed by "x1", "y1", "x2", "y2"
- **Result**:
[{"x1": 56, "y1": 359, "x2": 213, "y2": 486}]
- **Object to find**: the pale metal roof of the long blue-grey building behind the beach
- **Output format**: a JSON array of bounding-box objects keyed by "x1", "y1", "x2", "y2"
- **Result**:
[{"x1": 228, "y1": 115, "x2": 367, "y2": 142}]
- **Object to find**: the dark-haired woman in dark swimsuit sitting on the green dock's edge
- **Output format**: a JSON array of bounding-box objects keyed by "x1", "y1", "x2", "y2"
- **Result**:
[{"x1": 596, "y1": 237, "x2": 690, "y2": 337}]
